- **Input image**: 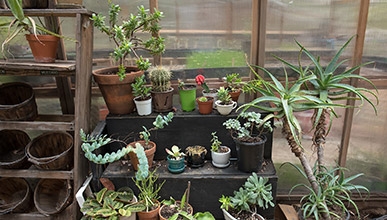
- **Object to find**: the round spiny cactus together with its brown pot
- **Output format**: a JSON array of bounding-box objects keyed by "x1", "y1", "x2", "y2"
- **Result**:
[{"x1": 149, "y1": 66, "x2": 174, "y2": 112}]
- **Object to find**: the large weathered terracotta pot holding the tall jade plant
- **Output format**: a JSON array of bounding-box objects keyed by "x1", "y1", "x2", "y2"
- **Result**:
[{"x1": 93, "y1": 66, "x2": 144, "y2": 115}]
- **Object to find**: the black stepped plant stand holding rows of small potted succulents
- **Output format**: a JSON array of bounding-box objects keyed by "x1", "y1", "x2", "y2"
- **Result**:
[{"x1": 92, "y1": 106, "x2": 278, "y2": 219}]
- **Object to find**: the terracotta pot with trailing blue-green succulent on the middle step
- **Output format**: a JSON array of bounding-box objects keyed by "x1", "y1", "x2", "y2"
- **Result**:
[{"x1": 128, "y1": 112, "x2": 173, "y2": 170}]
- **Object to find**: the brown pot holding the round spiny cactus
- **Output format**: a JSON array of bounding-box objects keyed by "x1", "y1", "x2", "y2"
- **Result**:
[{"x1": 151, "y1": 88, "x2": 174, "y2": 112}]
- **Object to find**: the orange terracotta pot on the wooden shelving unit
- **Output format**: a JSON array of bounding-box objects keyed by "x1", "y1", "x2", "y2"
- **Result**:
[{"x1": 26, "y1": 34, "x2": 59, "y2": 63}]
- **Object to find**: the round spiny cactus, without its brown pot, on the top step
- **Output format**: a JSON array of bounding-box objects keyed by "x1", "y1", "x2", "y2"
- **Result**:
[{"x1": 149, "y1": 66, "x2": 172, "y2": 92}]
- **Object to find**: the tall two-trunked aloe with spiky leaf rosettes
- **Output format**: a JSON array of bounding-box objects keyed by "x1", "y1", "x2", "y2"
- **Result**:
[{"x1": 240, "y1": 36, "x2": 378, "y2": 219}]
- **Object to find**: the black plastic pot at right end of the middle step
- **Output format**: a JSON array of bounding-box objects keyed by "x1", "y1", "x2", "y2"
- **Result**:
[{"x1": 234, "y1": 135, "x2": 267, "y2": 173}]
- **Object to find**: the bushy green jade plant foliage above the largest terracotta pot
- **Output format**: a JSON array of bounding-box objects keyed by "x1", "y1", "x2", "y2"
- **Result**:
[{"x1": 91, "y1": 1, "x2": 165, "y2": 80}]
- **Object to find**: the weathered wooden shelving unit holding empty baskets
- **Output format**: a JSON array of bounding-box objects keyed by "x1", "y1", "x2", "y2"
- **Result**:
[{"x1": 0, "y1": 9, "x2": 93, "y2": 220}]
